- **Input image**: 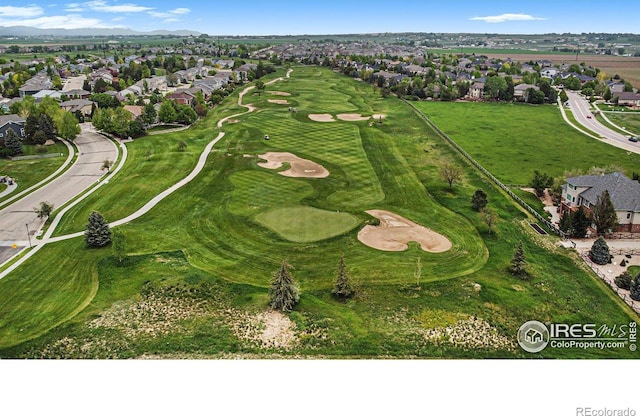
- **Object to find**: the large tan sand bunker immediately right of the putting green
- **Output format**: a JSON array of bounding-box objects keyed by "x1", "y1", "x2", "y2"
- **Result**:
[{"x1": 358, "y1": 209, "x2": 452, "y2": 253}]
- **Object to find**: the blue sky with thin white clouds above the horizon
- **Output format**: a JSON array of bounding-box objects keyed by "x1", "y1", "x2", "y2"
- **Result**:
[{"x1": 0, "y1": 0, "x2": 640, "y2": 35}]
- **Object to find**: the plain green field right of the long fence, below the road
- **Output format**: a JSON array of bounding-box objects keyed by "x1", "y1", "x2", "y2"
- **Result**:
[{"x1": 416, "y1": 102, "x2": 640, "y2": 185}]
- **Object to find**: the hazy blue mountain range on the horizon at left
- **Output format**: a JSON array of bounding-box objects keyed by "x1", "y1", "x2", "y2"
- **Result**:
[{"x1": 0, "y1": 26, "x2": 202, "y2": 37}]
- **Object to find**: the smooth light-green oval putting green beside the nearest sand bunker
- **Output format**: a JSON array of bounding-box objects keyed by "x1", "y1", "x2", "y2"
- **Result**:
[{"x1": 256, "y1": 206, "x2": 359, "y2": 243}]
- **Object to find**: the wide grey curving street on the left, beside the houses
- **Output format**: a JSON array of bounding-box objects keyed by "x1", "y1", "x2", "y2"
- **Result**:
[{"x1": 0, "y1": 123, "x2": 118, "y2": 247}]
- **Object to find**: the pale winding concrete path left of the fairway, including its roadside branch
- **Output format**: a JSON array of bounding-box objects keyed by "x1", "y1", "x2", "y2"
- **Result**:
[{"x1": 0, "y1": 69, "x2": 292, "y2": 279}]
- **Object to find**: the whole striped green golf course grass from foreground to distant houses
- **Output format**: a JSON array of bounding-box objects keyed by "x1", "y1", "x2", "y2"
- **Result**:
[{"x1": 0, "y1": 67, "x2": 637, "y2": 358}]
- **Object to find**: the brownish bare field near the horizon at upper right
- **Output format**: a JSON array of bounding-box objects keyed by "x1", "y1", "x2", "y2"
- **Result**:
[{"x1": 483, "y1": 51, "x2": 640, "y2": 88}]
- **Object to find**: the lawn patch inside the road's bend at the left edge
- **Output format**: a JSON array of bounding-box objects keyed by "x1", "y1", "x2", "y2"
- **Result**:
[{"x1": 0, "y1": 142, "x2": 69, "y2": 201}]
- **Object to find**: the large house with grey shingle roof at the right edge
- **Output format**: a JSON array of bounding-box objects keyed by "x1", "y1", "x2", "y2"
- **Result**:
[{"x1": 560, "y1": 172, "x2": 640, "y2": 233}]
